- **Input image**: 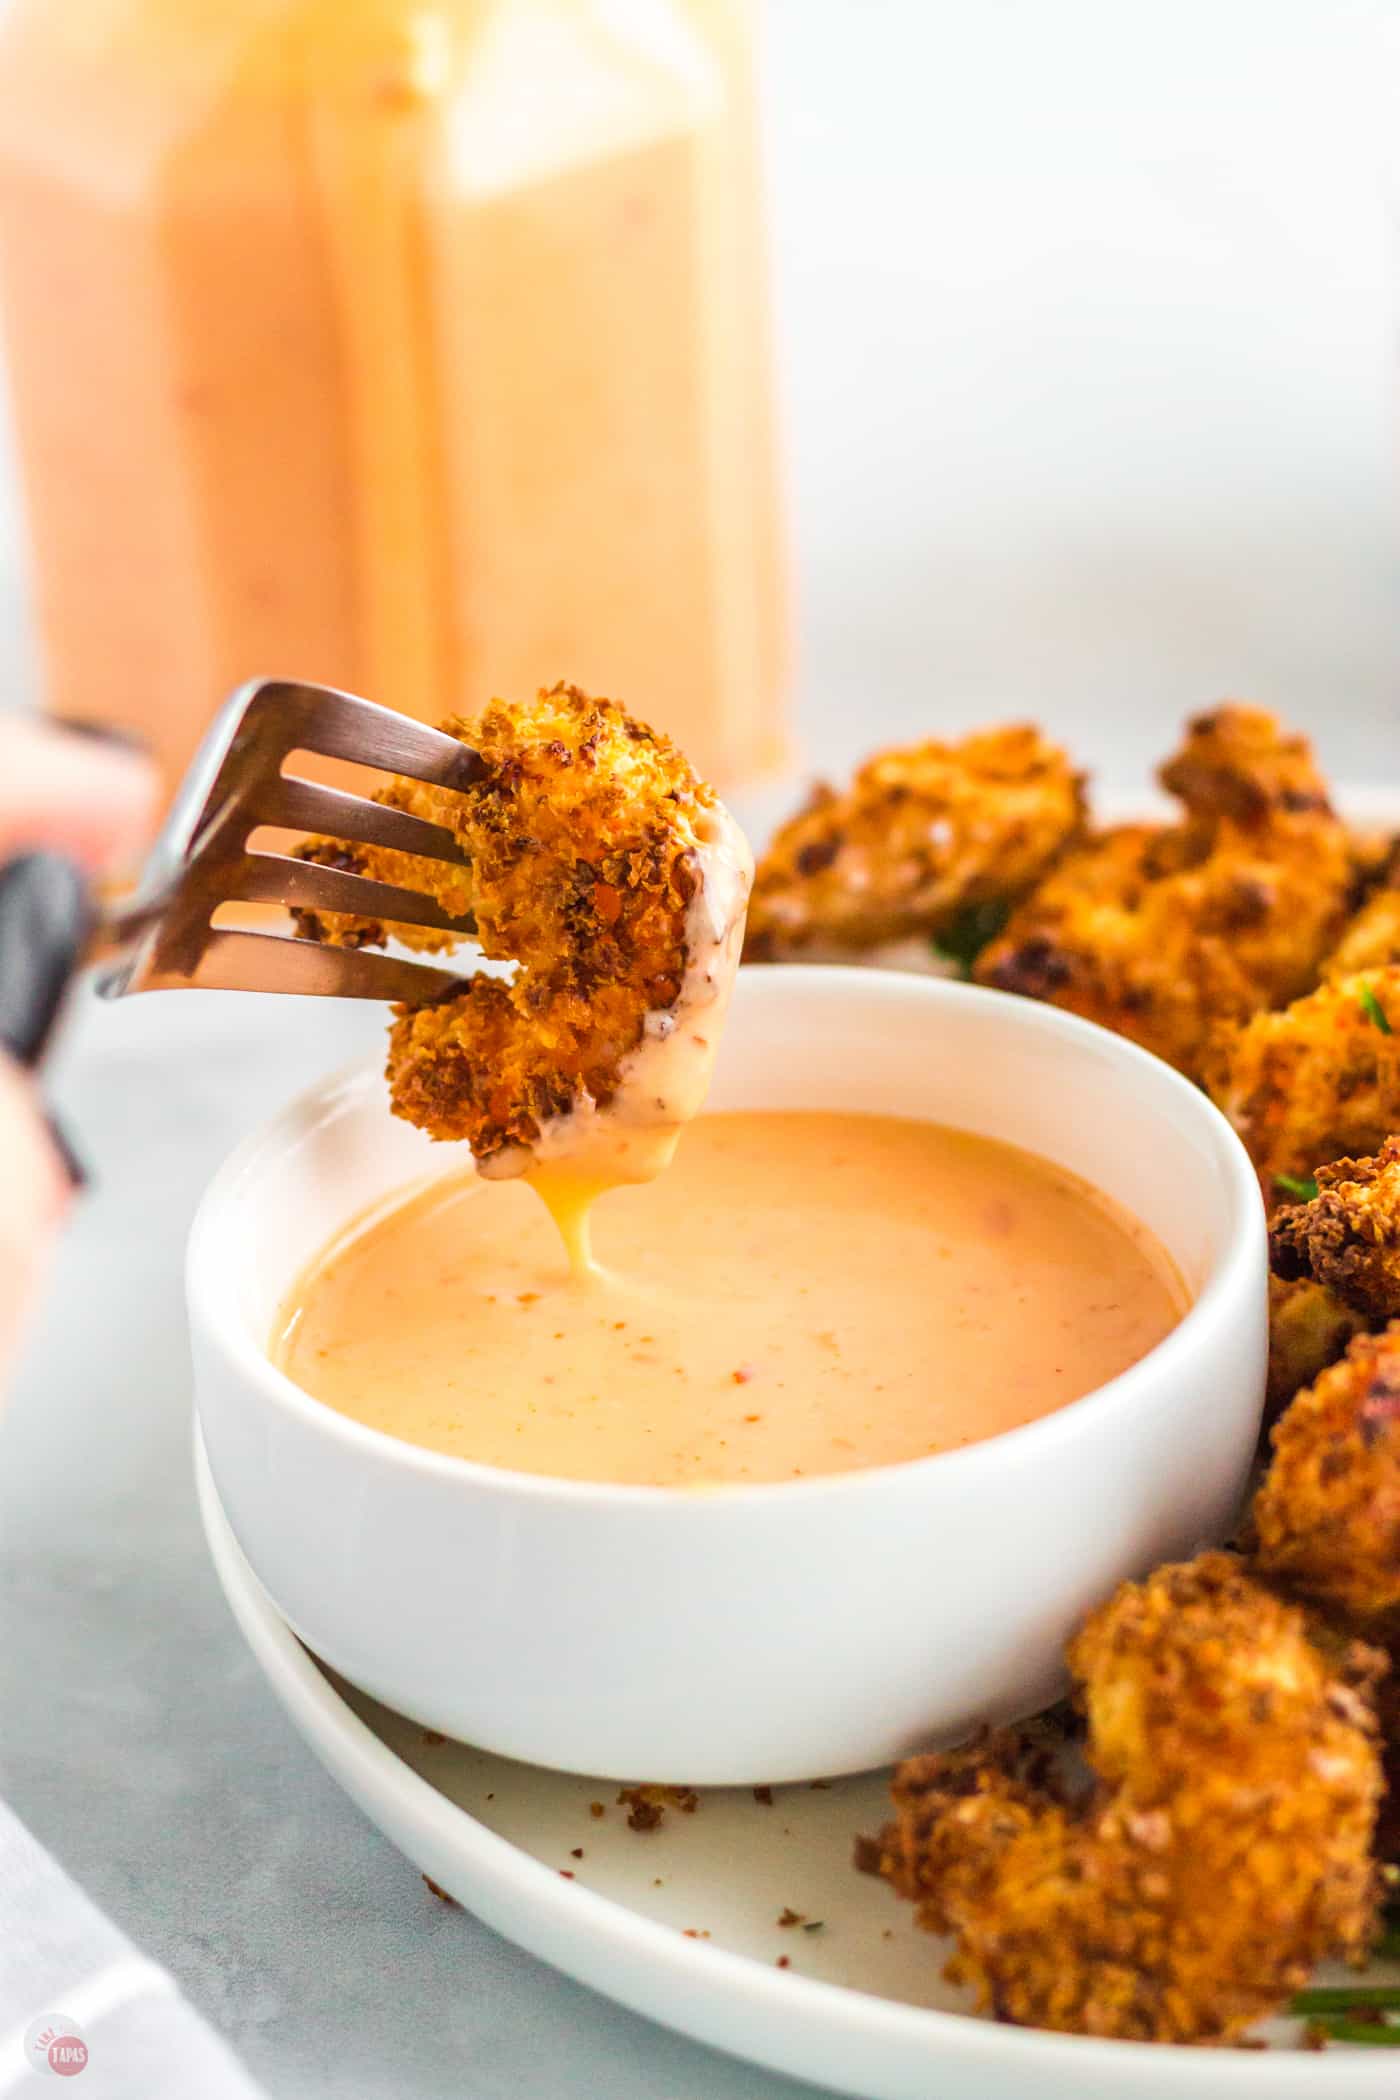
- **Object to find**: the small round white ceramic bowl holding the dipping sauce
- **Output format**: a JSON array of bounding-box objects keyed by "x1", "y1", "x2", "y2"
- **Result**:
[{"x1": 189, "y1": 966, "x2": 1268, "y2": 1785}]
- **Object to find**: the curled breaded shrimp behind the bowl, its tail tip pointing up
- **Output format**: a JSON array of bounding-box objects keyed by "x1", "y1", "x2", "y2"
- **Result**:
[{"x1": 974, "y1": 706, "x2": 1352, "y2": 1079}]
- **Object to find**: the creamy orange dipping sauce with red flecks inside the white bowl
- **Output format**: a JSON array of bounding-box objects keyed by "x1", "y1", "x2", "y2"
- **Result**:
[{"x1": 271, "y1": 1111, "x2": 1186, "y2": 1487}]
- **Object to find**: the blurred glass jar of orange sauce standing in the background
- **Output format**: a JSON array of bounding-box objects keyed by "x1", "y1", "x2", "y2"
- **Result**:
[{"x1": 0, "y1": 0, "x2": 783, "y2": 783}]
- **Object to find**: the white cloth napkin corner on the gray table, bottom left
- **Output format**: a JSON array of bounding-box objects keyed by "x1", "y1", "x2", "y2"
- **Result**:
[{"x1": 0, "y1": 1802, "x2": 260, "y2": 2100}]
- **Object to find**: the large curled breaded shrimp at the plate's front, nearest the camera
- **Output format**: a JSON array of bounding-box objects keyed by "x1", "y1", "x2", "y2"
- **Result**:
[{"x1": 879, "y1": 1554, "x2": 1381, "y2": 2041}]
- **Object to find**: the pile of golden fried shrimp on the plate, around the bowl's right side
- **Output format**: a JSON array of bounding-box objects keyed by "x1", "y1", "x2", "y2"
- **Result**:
[{"x1": 747, "y1": 706, "x2": 1400, "y2": 2043}]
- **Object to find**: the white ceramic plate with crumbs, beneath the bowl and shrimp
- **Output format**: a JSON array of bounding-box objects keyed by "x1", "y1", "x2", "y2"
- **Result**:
[{"x1": 195, "y1": 1441, "x2": 1400, "y2": 2100}]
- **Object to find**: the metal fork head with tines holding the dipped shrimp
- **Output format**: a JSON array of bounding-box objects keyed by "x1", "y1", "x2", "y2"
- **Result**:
[{"x1": 97, "y1": 678, "x2": 485, "y2": 1004}]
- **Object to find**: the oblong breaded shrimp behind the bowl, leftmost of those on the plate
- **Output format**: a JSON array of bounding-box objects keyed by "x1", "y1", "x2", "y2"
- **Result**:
[{"x1": 745, "y1": 725, "x2": 1083, "y2": 962}]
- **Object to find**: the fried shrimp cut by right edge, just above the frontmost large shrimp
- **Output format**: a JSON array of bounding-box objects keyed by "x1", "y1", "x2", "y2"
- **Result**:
[{"x1": 1253, "y1": 1321, "x2": 1400, "y2": 1640}]
